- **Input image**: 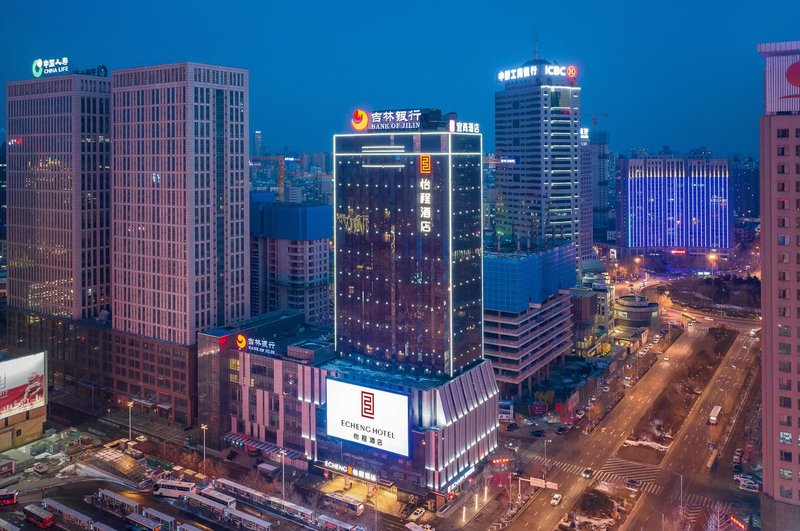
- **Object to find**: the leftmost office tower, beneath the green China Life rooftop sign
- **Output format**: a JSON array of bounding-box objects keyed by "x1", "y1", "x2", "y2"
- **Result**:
[{"x1": 6, "y1": 70, "x2": 111, "y2": 319}]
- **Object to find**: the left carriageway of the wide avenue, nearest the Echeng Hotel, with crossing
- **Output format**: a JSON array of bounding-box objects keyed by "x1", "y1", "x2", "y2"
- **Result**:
[{"x1": 509, "y1": 332, "x2": 699, "y2": 531}]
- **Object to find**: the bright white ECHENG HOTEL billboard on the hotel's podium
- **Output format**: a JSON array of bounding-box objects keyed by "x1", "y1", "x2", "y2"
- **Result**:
[{"x1": 326, "y1": 378, "x2": 409, "y2": 457}]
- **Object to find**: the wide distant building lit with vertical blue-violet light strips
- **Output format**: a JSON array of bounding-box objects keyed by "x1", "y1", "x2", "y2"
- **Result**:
[{"x1": 620, "y1": 156, "x2": 732, "y2": 256}]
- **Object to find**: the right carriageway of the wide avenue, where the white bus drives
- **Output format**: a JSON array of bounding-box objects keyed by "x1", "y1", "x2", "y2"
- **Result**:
[{"x1": 625, "y1": 333, "x2": 758, "y2": 531}]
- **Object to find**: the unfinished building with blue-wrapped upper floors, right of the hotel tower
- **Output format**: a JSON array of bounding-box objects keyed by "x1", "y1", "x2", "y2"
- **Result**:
[{"x1": 483, "y1": 241, "x2": 576, "y2": 398}]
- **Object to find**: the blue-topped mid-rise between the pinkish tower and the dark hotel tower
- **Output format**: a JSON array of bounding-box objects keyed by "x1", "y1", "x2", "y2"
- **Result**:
[{"x1": 250, "y1": 193, "x2": 333, "y2": 324}]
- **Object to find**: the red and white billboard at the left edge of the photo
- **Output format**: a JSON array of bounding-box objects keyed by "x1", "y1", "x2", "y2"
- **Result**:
[{"x1": 0, "y1": 352, "x2": 46, "y2": 419}]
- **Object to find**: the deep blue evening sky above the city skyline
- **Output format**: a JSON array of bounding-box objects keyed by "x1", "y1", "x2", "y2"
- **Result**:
[{"x1": 0, "y1": 0, "x2": 800, "y2": 156}]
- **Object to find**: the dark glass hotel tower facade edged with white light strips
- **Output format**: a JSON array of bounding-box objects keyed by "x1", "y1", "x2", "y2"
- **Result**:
[{"x1": 334, "y1": 132, "x2": 482, "y2": 376}]
